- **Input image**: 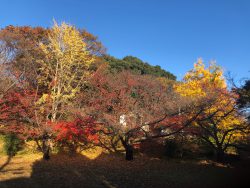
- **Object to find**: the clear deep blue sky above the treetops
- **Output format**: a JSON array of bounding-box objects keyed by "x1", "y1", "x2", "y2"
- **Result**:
[{"x1": 0, "y1": 0, "x2": 250, "y2": 79}]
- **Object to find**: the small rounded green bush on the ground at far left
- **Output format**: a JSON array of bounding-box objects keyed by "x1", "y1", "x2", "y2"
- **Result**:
[{"x1": 3, "y1": 134, "x2": 23, "y2": 156}]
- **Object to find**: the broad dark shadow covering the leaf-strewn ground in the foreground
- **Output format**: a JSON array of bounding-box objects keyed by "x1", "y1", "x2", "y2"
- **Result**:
[{"x1": 0, "y1": 154, "x2": 250, "y2": 188}]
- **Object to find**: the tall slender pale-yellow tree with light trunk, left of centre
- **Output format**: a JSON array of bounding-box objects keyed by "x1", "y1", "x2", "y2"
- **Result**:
[{"x1": 38, "y1": 22, "x2": 95, "y2": 122}]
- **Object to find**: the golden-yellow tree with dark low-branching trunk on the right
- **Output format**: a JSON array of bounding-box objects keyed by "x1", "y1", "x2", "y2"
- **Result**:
[{"x1": 175, "y1": 59, "x2": 248, "y2": 160}]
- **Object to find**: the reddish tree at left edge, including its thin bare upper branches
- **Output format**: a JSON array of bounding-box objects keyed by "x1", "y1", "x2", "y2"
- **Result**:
[{"x1": 0, "y1": 51, "x2": 41, "y2": 142}]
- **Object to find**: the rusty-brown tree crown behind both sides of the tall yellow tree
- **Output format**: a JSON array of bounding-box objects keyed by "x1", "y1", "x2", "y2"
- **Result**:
[{"x1": 0, "y1": 25, "x2": 106, "y2": 89}]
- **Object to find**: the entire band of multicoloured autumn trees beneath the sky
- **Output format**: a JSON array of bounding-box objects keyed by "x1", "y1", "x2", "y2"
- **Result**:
[{"x1": 0, "y1": 22, "x2": 249, "y2": 160}]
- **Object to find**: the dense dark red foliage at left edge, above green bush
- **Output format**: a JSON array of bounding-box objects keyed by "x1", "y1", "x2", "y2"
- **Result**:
[{"x1": 0, "y1": 88, "x2": 39, "y2": 139}]
